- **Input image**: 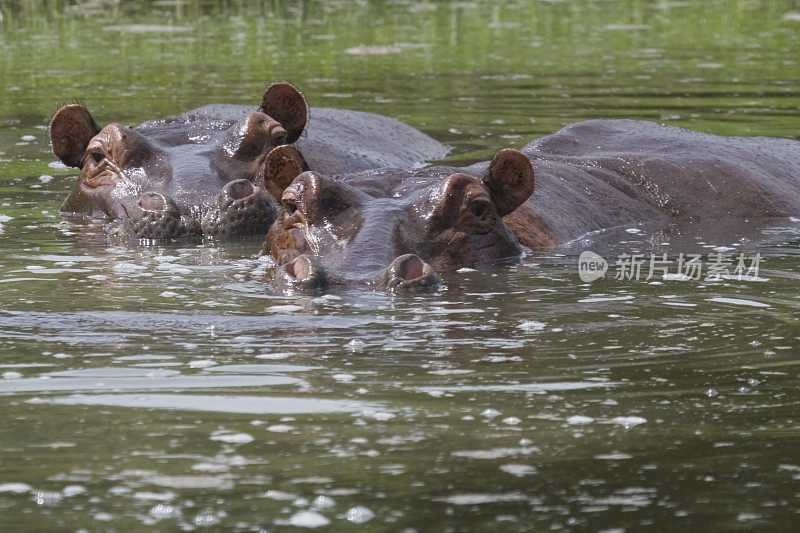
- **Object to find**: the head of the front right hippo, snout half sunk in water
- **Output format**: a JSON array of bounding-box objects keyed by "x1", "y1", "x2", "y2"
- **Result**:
[{"x1": 265, "y1": 150, "x2": 534, "y2": 290}]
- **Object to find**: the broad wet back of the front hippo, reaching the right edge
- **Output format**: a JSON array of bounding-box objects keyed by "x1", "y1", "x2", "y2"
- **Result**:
[{"x1": 468, "y1": 120, "x2": 800, "y2": 242}]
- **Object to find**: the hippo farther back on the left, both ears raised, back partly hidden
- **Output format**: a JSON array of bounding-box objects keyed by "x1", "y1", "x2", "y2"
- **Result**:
[{"x1": 50, "y1": 82, "x2": 447, "y2": 240}]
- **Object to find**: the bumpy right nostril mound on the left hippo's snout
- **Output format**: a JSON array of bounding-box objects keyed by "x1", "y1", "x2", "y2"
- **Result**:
[{"x1": 203, "y1": 179, "x2": 278, "y2": 237}]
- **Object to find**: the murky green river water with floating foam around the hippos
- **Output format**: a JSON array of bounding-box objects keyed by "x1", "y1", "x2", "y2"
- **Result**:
[{"x1": 0, "y1": 0, "x2": 800, "y2": 531}]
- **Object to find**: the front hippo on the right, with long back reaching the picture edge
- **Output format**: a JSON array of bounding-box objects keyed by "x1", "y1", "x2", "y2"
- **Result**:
[{"x1": 264, "y1": 120, "x2": 800, "y2": 289}]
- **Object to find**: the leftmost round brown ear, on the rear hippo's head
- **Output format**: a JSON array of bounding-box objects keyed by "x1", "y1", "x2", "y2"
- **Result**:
[{"x1": 50, "y1": 104, "x2": 100, "y2": 167}]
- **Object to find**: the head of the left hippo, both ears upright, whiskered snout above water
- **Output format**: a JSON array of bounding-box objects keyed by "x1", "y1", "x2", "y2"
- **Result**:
[{"x1": 50, "y1": 82, "x2": 308, "y2": 239}]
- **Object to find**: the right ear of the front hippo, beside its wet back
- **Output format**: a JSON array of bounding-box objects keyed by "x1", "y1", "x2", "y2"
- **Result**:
[{"x1": 482, "y1": 148, "x2": 534, "y2": 217}]
